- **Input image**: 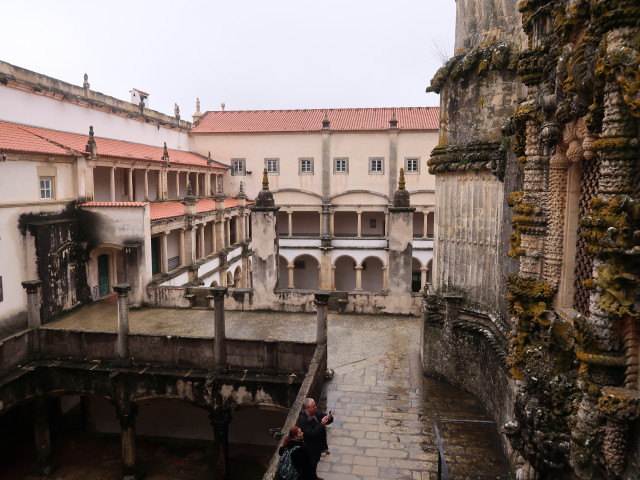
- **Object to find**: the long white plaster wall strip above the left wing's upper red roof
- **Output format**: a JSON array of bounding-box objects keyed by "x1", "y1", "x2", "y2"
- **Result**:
[{"x1": 0, "y1": 85, "x2": 189, "y2": 150}]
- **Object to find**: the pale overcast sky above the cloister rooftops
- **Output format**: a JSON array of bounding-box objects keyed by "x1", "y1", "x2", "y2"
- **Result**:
[{"x1": 0, "y1": 0, "x2": 455, "y2": 120}]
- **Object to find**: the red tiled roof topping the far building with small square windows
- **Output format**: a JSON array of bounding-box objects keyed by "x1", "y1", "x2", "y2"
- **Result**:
[{"x1": 191, "y1": 107, "x2": 440, "y2": 134}]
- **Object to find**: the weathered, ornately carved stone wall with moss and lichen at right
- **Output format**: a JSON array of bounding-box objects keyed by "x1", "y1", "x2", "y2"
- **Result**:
[{"x1": 424, "y1": 0, "x2": 640, "y2": 480}]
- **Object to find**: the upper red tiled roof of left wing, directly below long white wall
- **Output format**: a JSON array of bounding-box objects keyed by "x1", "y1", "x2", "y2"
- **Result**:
[{"x1": 0, "y1": 122, "x2": 229, "y2": 169}]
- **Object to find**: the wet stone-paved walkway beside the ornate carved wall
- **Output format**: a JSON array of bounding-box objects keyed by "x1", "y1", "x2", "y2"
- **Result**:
[{"x1": 318, "y1": 315, "x2": 510, "y2": 480}]
